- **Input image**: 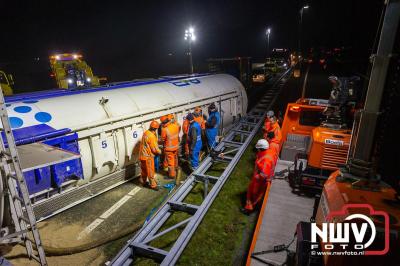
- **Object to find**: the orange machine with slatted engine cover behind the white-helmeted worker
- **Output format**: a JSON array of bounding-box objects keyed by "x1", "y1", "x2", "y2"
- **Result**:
[{"x1": 281, "y1": 78, "x2": 354, "y2": 193}]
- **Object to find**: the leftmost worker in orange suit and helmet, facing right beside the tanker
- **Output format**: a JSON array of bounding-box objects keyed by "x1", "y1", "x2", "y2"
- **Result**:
[{"x1": 139, "y1": 121, "x2": 161, "y2": 190}]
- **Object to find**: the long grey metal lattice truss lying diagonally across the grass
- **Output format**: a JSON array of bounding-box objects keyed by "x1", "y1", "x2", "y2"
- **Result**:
[{"x1": 110, "y1": 69, "x2": 291, "y2": 265}]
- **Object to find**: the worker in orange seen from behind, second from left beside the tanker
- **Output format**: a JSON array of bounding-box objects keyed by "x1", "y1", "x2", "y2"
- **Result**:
[{"x1": 161, "y1": 115, "x2": 181, "y2": 178}]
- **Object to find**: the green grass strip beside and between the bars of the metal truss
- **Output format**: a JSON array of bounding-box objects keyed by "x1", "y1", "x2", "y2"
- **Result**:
[{"x1": 135, "y1": 134, "x2": 258, "y2": 265}]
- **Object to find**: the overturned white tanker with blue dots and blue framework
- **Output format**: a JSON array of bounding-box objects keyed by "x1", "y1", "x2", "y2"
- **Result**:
[{"x1": 1, "y1": 74, "x2": 247, "y2": 220}]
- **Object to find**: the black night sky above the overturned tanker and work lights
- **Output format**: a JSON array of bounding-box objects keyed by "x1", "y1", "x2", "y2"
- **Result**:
[{"x1": 0, "y1": 0, "x2": 383, "y2": 90}]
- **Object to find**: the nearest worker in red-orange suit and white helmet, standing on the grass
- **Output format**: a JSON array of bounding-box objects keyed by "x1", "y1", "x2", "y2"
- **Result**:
[{"x1": 241, "y1": 139, "x2": 276, "y2": 215}]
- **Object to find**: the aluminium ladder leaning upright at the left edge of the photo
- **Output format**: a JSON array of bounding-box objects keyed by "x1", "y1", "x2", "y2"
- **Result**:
[{"x1": 0, "y1": 86, "x2": 47, "y2": 265}]
